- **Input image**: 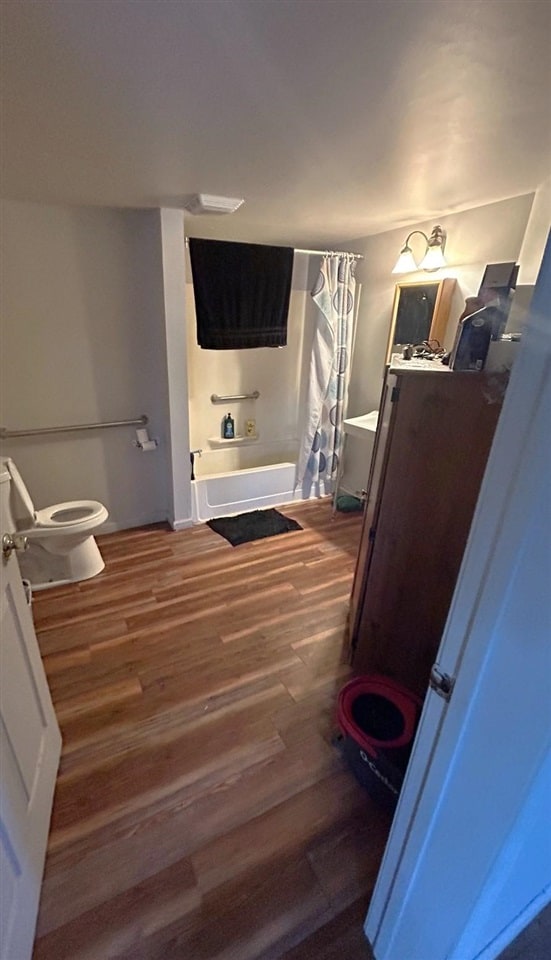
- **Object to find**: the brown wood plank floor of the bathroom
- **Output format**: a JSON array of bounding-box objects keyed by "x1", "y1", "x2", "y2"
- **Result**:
[{"x1": 33, "y1": 500, "x2": 390, "y2": 960}]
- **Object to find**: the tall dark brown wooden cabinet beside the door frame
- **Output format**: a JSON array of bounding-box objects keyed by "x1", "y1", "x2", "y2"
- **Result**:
[{"x1": 350, "y1": 359, "x2": 506, "y2": 697}]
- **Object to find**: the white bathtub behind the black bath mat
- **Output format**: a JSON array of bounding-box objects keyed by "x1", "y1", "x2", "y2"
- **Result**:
[{"x1": 191, "y1": 462, "x2": 303, "y2": 523}]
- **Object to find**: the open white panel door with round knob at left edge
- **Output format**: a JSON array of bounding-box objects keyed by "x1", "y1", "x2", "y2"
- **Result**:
[{"x1": 0, "y1": 472, "x2": 61, "y2": 960}]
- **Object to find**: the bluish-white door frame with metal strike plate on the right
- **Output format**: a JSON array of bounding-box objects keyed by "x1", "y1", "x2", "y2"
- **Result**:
[{"x1": 365, "y1": 232, "x2": 551, "y2": 960}]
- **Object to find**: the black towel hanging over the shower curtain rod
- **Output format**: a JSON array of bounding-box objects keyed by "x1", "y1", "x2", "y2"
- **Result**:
[{"x1": 189, "y1": 237, "x2": 294, "y2": 350}]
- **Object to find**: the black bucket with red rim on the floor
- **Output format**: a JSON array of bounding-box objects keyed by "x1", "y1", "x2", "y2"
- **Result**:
[{"x1": 337, "y1": 674, "x2": 422, "y2": 811}]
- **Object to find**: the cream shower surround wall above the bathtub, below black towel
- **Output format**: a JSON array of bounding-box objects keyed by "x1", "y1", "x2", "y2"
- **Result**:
[{"x1": 186, "y1": 254, "x2": 319, "y2": 476}]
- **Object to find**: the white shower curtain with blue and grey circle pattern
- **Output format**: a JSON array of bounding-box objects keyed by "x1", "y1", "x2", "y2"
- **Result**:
[{"x1": 297, "y1": 254, "x2": 356, "y2": 496}]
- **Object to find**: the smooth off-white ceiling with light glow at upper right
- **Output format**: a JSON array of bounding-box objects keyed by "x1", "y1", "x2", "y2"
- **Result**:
[{"x1": 0, "y1": 0, "x2": 551, "y2": 246}]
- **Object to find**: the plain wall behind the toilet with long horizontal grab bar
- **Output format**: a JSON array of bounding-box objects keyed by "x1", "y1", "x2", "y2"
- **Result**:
[{"x1": 0, "y1": 202, "x2": 168, "y2": 528}]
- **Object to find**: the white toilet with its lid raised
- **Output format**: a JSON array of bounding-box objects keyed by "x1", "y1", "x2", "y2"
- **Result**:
[{"x1": 2, "y1": 459, "x2": 109, "y2": 590}]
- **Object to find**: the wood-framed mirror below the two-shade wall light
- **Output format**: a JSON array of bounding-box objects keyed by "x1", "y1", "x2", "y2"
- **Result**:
[{"x1": 386, "y1": 278, "x2": 455, "y2": 363}]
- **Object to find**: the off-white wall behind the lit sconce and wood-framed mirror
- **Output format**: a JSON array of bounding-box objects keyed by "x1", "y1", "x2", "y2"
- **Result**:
[{"x1": 343, "y1": 194, "x2": 541, "y2": 492}]
